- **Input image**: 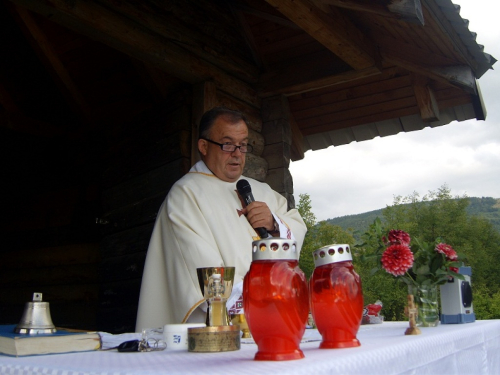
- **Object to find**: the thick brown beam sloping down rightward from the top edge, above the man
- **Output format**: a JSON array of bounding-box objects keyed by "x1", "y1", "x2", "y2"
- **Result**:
[{"x1": 266, "y1": 0, "x2": 376, "y2": 69}]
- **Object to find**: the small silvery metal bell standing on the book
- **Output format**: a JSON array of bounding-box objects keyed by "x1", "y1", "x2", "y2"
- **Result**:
[{"x1": 14, "y1": 293, "x2": 57, "y2": 334}]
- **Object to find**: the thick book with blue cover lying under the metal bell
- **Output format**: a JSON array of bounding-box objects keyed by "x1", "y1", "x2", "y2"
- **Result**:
[{"x1": 0, "y1": 324, "x2": 101, "y2": 357}]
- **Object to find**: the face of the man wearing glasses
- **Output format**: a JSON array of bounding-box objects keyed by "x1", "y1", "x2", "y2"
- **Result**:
[{"x1": 198, "y1": 116, "x2": 248, "y2": 182}]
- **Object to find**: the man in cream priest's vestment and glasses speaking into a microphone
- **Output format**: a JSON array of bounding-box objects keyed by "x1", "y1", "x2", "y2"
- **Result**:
[{"x1": 136, "y1": 107, "x2": 306, "y2": 331}]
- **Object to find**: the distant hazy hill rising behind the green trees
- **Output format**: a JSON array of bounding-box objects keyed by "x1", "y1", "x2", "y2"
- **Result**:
[{"x1": 326, "y1": 197, "x2": 500, "y2": 240}]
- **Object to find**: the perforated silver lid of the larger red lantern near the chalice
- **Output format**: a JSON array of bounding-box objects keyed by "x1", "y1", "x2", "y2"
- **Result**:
[{"x1": 252, "y1": 238, "x2": 299, "y2": 260}]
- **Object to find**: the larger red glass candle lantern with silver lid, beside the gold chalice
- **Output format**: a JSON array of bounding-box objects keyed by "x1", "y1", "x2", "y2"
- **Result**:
[{"x1": 243, "y1": 238, "x2": 309, "y2": 361}]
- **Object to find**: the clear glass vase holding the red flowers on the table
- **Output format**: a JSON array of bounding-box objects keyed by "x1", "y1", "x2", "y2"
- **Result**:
[{"x1": 408, "y1": 285, "x2": 439, "y2": 327}]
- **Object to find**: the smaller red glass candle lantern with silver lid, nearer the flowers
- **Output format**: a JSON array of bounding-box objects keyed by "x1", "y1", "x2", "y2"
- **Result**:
[{"x1": 309, "y1": 245, "x2": 363, "y2": 349}]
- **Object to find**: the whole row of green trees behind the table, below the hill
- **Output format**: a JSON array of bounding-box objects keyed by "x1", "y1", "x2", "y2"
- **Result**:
[{"x1": 297, "y1": 185, "x2": 500, "y2": 320}]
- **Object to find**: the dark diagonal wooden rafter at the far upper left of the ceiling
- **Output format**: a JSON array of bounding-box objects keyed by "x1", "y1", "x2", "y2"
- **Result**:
[{"x1": 15, "y1": 6, "x2": 92, "y2": 121}]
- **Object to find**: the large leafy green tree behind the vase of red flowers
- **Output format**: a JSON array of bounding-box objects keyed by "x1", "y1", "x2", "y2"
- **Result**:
[{"x1": 357, "y1": 185, "x2": 500, "y2": 320}]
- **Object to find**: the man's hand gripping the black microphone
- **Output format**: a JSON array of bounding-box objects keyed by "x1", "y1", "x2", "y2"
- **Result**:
[{"x1": 236, "y1": 180, "x2": 274, "y2": 238}]
